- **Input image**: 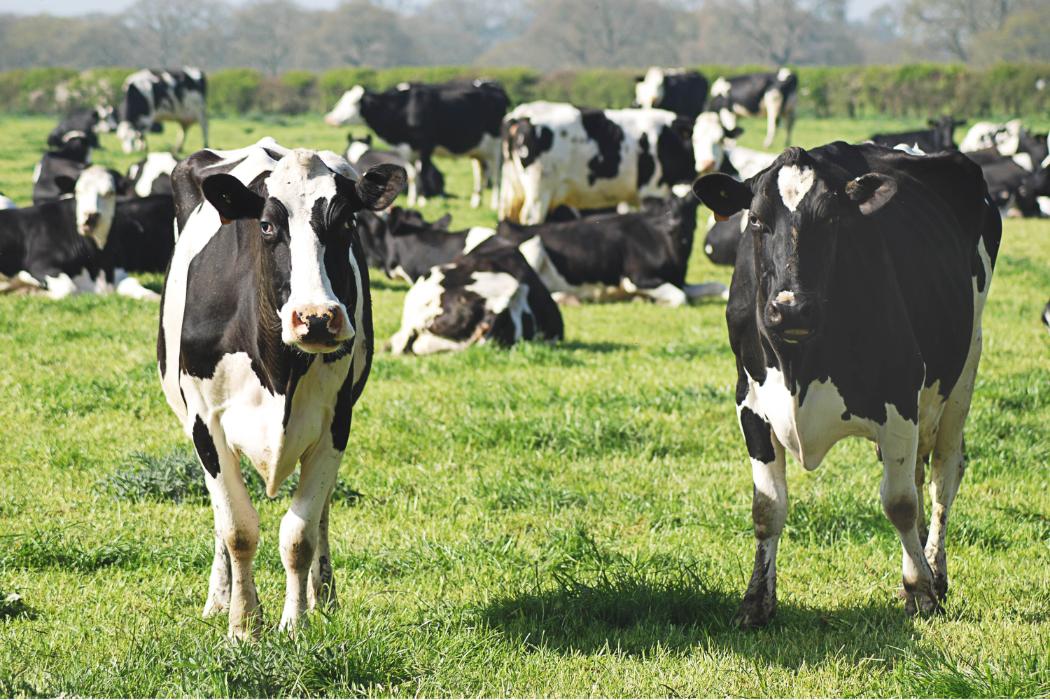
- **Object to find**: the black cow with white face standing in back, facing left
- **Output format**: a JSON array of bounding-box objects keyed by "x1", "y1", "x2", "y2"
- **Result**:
[{"x1": 324, "y1": 81, "x2": 510, "y2": 207}]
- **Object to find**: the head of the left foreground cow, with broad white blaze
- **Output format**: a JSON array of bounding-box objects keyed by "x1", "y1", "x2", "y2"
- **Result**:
[{"x1": 202, "y1": 150, "x2": 405, "y2": 353}]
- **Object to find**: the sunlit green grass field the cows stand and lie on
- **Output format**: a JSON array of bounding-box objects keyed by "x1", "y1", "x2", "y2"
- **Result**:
[{"x1": 0, "y1": 116, "x2": 1050, "y2": 697}]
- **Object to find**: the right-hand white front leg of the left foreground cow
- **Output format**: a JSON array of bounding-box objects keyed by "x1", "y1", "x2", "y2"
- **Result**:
[{"x1": 280, "y1": 438, "x2": 342, "y2": 631}]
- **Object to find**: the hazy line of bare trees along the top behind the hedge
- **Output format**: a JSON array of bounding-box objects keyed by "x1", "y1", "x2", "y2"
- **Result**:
[{"x1": 0, "y1": 0, "x2": 1050, "y2": 71}]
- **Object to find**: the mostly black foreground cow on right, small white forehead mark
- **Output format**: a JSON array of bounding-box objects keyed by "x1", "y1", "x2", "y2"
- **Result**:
[{"x1": 694, "y1": 143, "x2": 1002, "y2": 627}]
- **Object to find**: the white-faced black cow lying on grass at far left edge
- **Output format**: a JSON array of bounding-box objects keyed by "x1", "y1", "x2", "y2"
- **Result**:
[{"x1": 0, "y1": 166, "x2": 158, "y2": 299}]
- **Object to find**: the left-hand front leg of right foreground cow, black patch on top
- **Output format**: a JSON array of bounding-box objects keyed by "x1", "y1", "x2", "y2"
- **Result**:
[{"x1": 737, "y1": 406, "x2": 788, "y2": 629}]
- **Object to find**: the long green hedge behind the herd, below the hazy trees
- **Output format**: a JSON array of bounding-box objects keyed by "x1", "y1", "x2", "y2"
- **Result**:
[{"x1": 0, "y1": 63, "x2": 1050, "y2": 119}]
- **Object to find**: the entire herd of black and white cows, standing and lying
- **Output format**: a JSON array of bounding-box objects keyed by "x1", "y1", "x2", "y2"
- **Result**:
[{"x1": 0, "y1": 62, "x2": 1050, "y2": 637}]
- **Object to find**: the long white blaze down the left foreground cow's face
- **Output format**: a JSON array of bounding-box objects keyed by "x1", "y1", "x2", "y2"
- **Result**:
[{"x1": 266, "y1": 149, "x2": 355, "y2": 344}]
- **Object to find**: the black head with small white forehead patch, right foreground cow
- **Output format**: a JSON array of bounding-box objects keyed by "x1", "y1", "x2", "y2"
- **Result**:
[{"x1": 693, "y1": 148, "x2": 897, "y2": 346}]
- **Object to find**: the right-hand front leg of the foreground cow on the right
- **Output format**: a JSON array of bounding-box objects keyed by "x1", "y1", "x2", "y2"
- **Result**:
[{"x1": 878, "y1": 410, "x2": 940, "y2": 615}]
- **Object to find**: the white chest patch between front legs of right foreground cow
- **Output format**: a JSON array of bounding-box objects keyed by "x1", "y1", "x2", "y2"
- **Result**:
[{"x1": 744, "y1": 367, "x2": 878, "y2": 469}]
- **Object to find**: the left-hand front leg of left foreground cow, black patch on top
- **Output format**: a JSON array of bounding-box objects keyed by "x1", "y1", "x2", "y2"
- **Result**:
[{"x1": 193, "y1": 418, "x2": 263, "y2": 639}]
